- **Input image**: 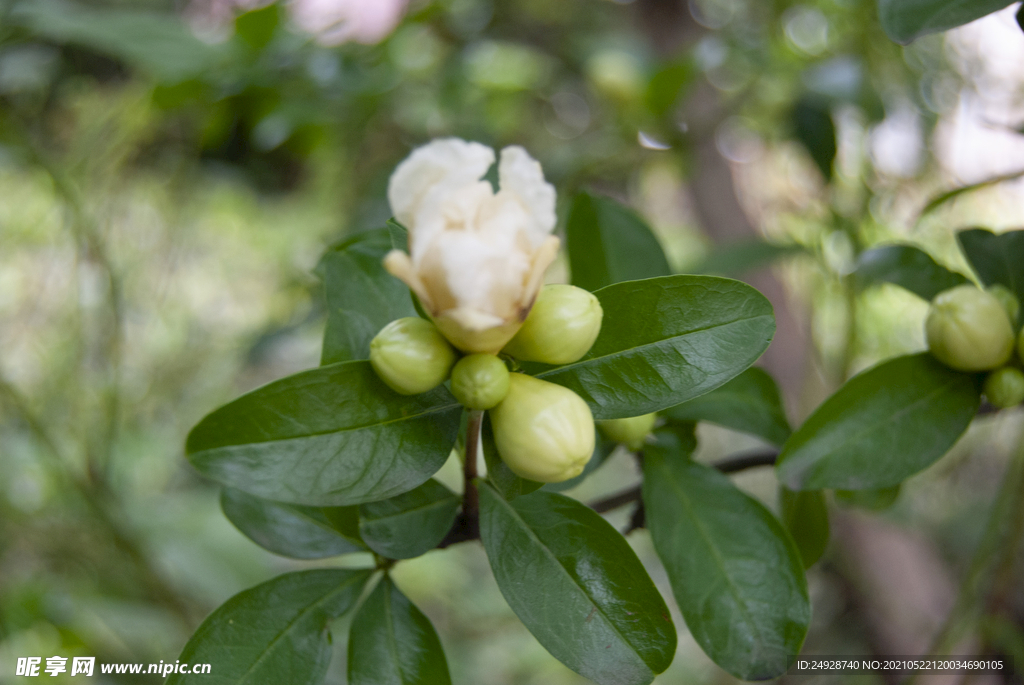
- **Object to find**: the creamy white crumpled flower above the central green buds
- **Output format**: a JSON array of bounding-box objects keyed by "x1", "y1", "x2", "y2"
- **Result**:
[{"x1": 384, "y1": 138, "x2": 559, "y2": 353}]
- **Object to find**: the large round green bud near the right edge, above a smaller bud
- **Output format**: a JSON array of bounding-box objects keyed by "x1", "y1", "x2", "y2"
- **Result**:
[{"x1": 925, "y1": 286, "x2": 1014, "y2": 371}]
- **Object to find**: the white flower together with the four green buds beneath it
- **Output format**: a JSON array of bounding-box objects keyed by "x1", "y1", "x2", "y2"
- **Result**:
[{"x1": 370, "y1": 138, "x2": 638, "y2": 482}]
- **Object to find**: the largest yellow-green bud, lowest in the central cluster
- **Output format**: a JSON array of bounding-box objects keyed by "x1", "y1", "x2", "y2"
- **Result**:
[{"x1": 490, "y1": 374, "x2": 594, "y2": 483}]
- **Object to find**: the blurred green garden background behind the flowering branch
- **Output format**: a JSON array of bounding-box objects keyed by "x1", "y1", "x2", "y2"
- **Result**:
[{"x1": 0, "y1": 0, "x2": 1024, "y2": 685}]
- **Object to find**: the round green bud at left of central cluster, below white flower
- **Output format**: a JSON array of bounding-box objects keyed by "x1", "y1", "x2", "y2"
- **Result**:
[{"x1": 370, "y1": 316, "x2": 455, "y2": 395}]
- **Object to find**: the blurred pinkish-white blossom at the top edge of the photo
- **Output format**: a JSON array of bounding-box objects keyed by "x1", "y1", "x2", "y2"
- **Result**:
[{"x1": 288, "y1": 0, "x2": 408, "y2": 45}]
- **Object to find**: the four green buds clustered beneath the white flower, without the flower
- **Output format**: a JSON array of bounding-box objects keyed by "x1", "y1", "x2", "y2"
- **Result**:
[{"x1": 370, "y1": 286, "x2": 603, "y2": 482}]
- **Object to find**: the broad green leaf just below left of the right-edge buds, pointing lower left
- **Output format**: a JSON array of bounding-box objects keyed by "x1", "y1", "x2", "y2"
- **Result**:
[{"x1": 775, "y1": 353, "x2": 981, "y2": 489}]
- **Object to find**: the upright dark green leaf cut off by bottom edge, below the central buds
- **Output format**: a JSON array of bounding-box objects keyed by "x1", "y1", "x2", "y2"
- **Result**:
[{"x1": 348, "y1": 575, "x2": 452, "y2": 685}]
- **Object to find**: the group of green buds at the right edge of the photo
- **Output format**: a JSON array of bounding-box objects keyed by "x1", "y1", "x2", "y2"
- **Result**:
[{"x1": 925, "y1": 285, "x2": 1024, "y2": 409}]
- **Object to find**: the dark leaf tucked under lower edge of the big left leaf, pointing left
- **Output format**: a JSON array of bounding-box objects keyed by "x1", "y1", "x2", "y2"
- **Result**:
[{"x1": 220, "y1": 487, "x2": 367, "y2": 559}]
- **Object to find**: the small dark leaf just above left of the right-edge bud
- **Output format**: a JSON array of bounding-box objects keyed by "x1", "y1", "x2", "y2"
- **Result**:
[{"x1": 855, "y1": 245, "x2": 971, "y2": 300}]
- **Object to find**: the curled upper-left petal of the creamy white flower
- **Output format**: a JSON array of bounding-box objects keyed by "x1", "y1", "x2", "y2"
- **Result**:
[{"x1": 387, "y1": 138, "x2": 495, "y2": 231}]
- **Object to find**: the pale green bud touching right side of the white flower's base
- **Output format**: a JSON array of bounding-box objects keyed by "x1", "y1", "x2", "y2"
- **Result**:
[{"x1": 504, "y1": 286, "x2": 604, "y2": 363}]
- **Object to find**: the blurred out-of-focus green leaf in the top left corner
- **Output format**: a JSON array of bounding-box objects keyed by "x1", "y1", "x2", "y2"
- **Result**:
[{"x1": 5, "y1": 0, "x2": 224, "y2": 83}]
